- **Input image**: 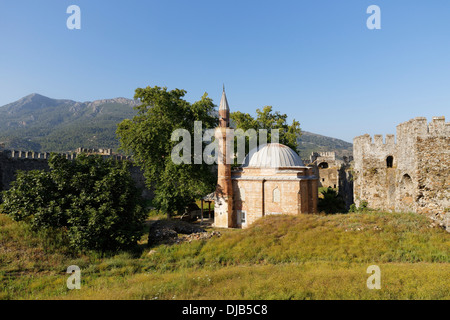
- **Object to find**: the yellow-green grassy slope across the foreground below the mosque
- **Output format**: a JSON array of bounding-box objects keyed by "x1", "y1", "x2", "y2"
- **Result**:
[{"x1": 0, "y1": 213, "x2": 450, "y2": 299}]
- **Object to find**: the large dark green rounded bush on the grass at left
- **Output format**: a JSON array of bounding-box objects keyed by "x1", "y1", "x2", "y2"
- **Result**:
[{"x1": 2, "y1": 154, "x2": 146, "y2": 251}]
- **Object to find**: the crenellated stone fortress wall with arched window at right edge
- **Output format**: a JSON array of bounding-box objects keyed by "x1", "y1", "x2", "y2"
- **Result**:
[{"x1": 353, "y1": 117, "x2": 450, "y2": 230}]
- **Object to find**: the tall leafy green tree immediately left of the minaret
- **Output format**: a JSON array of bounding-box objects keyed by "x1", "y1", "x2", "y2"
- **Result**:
[{"x1": 117, "y1": 86, "x2": 218, "y2": 216}]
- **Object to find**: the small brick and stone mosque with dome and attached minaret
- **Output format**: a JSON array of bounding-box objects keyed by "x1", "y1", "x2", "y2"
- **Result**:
[{"x1": 214, "y1": 90, "x2": 318, "y2": 228}]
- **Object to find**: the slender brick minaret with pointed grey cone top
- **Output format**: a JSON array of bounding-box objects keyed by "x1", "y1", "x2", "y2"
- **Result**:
[{"x1": 214, "y1": 86, "x2": 234, "y2": 228}]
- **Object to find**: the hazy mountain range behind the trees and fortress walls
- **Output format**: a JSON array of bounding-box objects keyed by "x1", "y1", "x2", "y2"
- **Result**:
[{"x1": 0, "y1": 93, "x2": 352, "y2": 158}]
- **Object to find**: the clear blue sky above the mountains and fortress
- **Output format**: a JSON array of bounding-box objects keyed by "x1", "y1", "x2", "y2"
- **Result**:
[{"x1": 0, "y1": 0, "x2": 450, "y2": 142}]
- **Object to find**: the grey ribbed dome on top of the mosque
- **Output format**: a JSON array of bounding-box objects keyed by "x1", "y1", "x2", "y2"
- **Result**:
[{"x1": 242, "y1": 143, "x2": 304, "y2": 168}]
